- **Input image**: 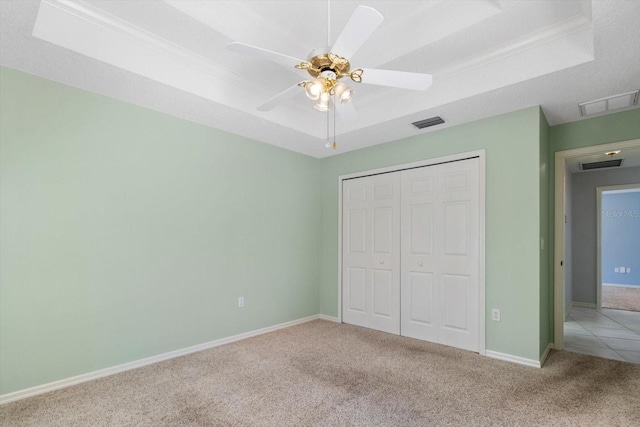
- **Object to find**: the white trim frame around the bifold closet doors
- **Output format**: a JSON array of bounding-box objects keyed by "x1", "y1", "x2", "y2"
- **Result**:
[{"x1": 338, "y1": 150, "x2": 486, "y2": 355}]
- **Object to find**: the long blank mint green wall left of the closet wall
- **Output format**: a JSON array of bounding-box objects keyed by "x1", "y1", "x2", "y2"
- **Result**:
[{"x1": 0, "y1": 68, "x2": 320, "y2": 394}]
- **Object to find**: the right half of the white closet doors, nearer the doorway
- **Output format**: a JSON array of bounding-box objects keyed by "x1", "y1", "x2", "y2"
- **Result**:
[{"x1": 401, "y1": 159, "x2": 479, "y2": 351}]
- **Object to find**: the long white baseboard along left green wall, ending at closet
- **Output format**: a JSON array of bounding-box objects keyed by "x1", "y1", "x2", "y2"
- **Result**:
[{"x1": 0, "y1": 314, "x2": 324, "y2": 405}]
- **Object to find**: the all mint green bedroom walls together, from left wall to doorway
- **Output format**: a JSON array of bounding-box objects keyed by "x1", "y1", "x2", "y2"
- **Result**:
[{"x1": 5, "y1": 63, "x2": 640, "y2": 394}]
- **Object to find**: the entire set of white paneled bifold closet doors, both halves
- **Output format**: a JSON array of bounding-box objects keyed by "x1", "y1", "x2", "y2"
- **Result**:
[{"x1": 342, "y1": 158, "x2": 480, "y2": 351}]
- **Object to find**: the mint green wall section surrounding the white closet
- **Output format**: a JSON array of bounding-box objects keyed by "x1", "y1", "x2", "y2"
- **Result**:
[{"x1": 320, "y1": 107, "x2": 542, "y2": 360}]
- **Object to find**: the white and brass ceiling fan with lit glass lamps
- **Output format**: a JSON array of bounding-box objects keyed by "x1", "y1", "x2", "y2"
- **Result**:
[{"x1": 227, "y1": 6, "x2": 433, "y2": 122}]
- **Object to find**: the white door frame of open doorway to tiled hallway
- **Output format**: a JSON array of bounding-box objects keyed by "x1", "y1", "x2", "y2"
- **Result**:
[{"x1": 553, "y1": 139, "x2": 640, "y2": 350}]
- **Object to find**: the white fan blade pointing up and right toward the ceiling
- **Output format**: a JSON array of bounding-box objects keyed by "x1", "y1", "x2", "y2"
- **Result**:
[{"x1": 331, "y1": 6, "x2": 384, "y2": 58}]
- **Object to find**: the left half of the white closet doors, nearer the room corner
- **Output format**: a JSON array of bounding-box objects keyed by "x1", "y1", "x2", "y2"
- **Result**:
[{"x1": 342, "y1": 172, "x2": 400, "y2": 334}]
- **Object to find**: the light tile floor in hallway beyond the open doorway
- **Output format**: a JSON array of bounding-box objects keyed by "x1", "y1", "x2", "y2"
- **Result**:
[{"x1": 564, "y1": 307, "x2": 640, "y2": 364}]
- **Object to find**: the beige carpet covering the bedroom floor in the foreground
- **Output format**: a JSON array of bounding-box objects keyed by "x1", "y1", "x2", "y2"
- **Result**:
[{"x1": 0, "y1": 320, "x2": 640, "y2": 427}]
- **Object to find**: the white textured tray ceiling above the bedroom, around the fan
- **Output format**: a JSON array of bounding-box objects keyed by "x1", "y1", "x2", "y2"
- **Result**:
[{"x1": 0, "y1": 0, "x2": 640, "y2": 157}]
